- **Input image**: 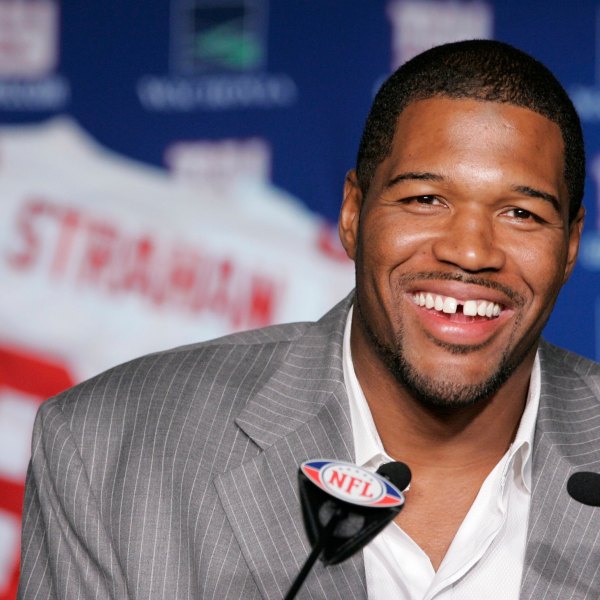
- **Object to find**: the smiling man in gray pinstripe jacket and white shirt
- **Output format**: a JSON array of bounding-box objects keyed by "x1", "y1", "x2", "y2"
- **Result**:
[{"x1": 20, "y1": 41, "x2": 600, "y2": 600}]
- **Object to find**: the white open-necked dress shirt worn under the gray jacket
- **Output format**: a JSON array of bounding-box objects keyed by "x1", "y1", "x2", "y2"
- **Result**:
[{"x1": 343, "y1": 309, "x2": 540, "y2": 600}]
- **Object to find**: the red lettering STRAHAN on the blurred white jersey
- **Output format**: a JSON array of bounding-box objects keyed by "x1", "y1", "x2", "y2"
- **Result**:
[{"x1": 7, "y1": 197, "x2": 283, "y2": 329}]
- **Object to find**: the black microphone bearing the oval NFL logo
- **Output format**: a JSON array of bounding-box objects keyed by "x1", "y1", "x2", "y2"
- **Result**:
[{"x1": 284, "y1": 459, "x2": 411, "y2": 600}]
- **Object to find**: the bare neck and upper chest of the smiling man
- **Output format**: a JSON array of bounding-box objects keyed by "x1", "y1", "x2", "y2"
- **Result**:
[{"x1": 349, "y1": 308, "x2": 535, "y2": 570}]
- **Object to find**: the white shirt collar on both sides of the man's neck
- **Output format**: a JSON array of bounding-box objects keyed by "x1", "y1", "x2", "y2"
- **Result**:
[{"x1": 342, "y1": 306, "x2": 541, "y2": 493}]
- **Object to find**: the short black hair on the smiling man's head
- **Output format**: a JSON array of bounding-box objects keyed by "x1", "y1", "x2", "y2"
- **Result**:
[{"x1": 356, "y1": 40, "x2": 585, "y2": 220}]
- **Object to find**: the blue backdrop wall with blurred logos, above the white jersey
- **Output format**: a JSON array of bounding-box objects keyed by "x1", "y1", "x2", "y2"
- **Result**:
[{"x1": 0, "y1": 0, "x2": 600, "y2": 358}]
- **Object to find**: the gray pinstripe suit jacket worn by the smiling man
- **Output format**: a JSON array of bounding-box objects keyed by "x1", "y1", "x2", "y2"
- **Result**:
[{"x1": 19, "y1": 299, "x2": 600, "y2": 600}]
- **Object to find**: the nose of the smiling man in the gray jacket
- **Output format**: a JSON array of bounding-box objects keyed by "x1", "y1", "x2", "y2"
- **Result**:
[{"x1": 433, "y1": 212, "x2": 506, "y2": 272}]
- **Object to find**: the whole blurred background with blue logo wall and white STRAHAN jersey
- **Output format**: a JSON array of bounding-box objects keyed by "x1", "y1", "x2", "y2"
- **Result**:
[{"x1": 0, "y1": 0, "x2": 600, "y2": 600}]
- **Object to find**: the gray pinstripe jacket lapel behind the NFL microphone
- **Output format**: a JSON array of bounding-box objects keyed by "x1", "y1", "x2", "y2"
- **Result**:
[{"x1": 215, "y1": 299, "x2": 366, "y2": 600}]
